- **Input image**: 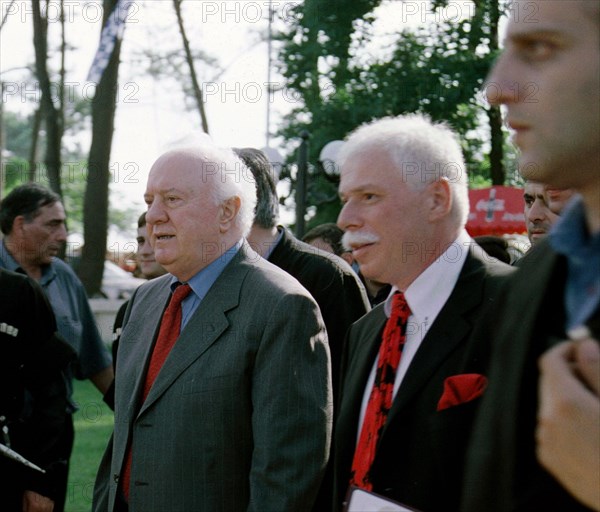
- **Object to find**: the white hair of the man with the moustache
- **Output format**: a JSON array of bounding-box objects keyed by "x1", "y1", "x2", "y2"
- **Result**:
[{"x1": 337, "y1": 114, "x2": 469, "y2": 227}]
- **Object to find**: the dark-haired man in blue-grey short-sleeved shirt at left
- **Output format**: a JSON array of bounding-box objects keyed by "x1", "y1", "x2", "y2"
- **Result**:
[{"x1": 0, "y1": 183, "x2": 114, "y2": 512}]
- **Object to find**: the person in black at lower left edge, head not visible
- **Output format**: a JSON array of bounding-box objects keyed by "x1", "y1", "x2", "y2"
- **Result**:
[{"x1": 0, "y1": 268, "x2": 75, "y2": 512}]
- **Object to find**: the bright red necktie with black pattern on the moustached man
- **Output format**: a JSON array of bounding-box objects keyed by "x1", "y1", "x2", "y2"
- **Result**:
[{"x1": 350, "y1": 292, "x2": 410, "y2": 491}]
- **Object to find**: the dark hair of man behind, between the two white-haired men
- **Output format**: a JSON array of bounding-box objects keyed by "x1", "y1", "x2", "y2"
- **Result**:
[{"x1": 233, "y1": 148, "x2": 279, "y2": 229}]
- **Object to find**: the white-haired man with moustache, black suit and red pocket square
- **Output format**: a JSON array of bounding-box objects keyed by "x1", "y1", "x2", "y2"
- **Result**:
[{"x1": 333, "y1": 115, "x2": 512, "y2": 512}]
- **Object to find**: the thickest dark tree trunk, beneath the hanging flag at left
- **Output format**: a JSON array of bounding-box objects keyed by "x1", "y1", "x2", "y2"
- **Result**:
[{"x1": 79, "y1": 0, "x2": 121, "y2": 296}]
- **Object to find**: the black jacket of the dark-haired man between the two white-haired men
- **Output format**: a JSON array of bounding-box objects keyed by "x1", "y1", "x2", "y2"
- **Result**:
[{"x1": 269, "y1": 229, "x2": 371, "y2": 397}]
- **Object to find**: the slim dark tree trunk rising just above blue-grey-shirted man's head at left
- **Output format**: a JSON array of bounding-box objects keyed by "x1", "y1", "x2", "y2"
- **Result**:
[{"x1": 31, "y1": 0, "x2": 63, "y2": 197}]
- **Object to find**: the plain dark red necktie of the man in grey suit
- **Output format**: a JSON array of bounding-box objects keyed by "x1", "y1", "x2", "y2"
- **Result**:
[{"x1": 121, "y1": 284, "x2": 192, "y2": 501}]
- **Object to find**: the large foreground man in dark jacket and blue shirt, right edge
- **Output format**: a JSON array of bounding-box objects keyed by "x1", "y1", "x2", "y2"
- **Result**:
[{"x1": 462, "y1": 0, "x2": 600, "y2": 512}]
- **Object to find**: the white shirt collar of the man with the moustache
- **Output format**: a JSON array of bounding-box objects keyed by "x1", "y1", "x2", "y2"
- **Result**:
[{"x1": 384, "y1": 230, "x2": 474, "y2": 326}]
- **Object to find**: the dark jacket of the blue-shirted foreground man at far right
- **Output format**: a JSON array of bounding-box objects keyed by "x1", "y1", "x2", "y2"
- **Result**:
[{"x1": 462, "y1": 241, "x2": 600, "y2": 512}]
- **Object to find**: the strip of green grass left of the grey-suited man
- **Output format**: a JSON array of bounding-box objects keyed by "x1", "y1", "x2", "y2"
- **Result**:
[{"x1": 65, "y1": 380, "x2": 114, "y2": 512}]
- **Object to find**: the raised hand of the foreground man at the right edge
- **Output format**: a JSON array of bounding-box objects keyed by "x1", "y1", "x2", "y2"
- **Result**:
[{"x1": 536, "y1": 338, "x2": 600, "y2": 511}]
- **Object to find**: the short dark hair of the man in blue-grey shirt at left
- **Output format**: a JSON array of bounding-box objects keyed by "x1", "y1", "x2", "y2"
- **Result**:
[{"x1": 0, "y1": 183, "x2": 61, "y2": 235}]
